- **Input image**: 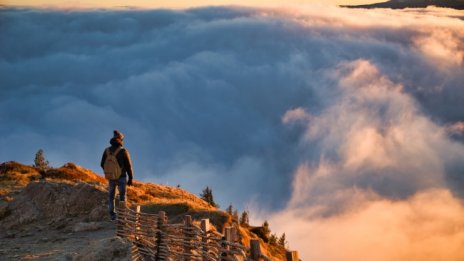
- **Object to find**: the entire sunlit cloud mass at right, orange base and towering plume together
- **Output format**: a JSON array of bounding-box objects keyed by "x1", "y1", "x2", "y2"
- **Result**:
[{"x1": 267, "y1": 49, "x2": 464, "y2": 260}]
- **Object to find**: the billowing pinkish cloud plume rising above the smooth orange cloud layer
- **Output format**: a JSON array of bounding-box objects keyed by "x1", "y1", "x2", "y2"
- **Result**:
[{"x1": 280, "y1": 60, "x2": 464, "y2": 208}]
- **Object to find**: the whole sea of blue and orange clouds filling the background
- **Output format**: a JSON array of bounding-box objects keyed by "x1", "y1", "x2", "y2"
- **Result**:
[{"x1": 0, "y1": 6, "x2": 464, "y2": 260}]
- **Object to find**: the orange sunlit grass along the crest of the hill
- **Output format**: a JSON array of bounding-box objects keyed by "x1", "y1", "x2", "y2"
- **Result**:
[{"x1": 0, "y1": 162, "x2": 285, "y2": 260}]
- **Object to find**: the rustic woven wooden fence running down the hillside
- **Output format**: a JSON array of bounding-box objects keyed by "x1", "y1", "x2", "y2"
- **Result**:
[{"x1": 116, "y1": 202, "x2": 299, "y2": 261}]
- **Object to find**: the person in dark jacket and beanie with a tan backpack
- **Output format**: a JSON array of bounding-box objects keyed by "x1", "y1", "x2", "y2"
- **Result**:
[{"x1": 100, "y1": 130, "x2": 133, "y2": 220}]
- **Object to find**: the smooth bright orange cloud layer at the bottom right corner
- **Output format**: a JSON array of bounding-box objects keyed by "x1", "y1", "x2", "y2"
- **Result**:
[{"x1": 270, "y1": 190, "x2": 464, "y2": 261}]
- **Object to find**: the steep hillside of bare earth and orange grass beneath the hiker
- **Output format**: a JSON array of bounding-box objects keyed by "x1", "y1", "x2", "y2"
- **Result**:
[{"x1": 0, "y1": 162, "x2": 285, "y2": 260}]
